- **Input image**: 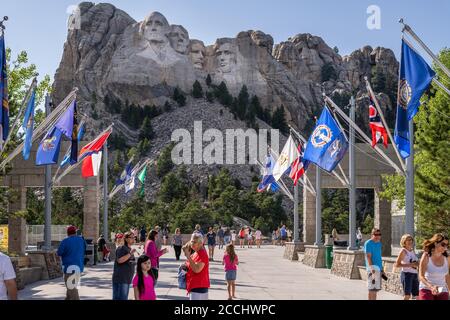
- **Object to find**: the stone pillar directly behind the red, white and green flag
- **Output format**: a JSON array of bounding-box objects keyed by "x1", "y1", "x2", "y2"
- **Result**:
[{"x1": 83, "y1": 177, "x2": 100, "y2": 242}]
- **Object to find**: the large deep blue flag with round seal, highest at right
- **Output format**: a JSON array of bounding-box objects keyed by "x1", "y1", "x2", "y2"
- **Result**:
[{"x1": 394, "y1": 40, "x2": 436, "y2": 159}]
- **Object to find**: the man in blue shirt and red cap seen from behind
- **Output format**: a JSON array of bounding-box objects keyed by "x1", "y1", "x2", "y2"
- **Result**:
[{"x1": 57, "y1": 226, "x2": 86, "y2": 300}]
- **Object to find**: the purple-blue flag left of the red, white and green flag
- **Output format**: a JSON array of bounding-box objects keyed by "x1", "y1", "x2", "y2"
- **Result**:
[{"x1": 36, "y1": 101, "x2": 78, "y2": 166}]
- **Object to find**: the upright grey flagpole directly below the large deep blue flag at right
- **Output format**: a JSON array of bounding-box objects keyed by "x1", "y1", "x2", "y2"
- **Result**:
[{"x1": 405, "y1": 120, "x2": 414, "y2": 237}]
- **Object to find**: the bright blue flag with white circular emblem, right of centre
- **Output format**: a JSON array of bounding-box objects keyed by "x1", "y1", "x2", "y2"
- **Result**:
[{"x1": 303, "y1": 107, "x2": 348, "y2": 172}]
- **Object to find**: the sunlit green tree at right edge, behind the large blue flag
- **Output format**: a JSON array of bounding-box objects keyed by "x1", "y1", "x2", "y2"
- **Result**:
[{"x1": 414, "y1": 49, "x2": 450, "y2": 237}]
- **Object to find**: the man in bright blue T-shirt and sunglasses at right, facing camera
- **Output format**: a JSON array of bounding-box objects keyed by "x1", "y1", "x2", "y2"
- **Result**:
[{"x1": 364, "y1": 228, "x2": 384, "y2": 300}]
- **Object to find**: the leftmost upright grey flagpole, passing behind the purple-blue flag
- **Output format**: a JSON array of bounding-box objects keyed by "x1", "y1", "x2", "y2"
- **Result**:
[{"x1": 43, "y1": 93, "x2": 52, "y2": 251}]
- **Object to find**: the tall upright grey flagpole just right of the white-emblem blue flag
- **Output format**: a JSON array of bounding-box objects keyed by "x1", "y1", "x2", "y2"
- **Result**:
[{"x1": 348, "y1": 96, "x2": 357, "y2": 250}]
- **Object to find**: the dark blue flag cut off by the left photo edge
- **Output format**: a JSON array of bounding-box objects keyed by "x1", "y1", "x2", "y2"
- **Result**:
[{"x1": 0, "y1": 34, "x2": 9, "y2": 151}]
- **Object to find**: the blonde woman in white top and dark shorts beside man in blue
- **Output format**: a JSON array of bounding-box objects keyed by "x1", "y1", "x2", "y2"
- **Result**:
[{"x1": 395, "y1": 234, "x2": 419, "y2": 300}]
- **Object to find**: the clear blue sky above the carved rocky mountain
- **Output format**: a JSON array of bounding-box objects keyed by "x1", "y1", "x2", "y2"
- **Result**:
[{"x1": 0, "y1": 0, "x2": 450, "y2": 86}]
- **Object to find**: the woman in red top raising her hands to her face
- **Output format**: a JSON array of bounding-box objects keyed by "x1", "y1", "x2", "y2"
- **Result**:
[{"x1": 183, "y1": 234, "x2": 210, "y2": 300}]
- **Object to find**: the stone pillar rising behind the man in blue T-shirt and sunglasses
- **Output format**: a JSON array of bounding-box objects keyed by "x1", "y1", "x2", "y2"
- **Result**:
[{"x1": 374, "y1": 188, "x2": 392, "y2": 257}]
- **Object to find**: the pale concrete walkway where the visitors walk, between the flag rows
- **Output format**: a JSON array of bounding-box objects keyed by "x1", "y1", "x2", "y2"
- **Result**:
[{"x1": 19, "y1": 246, "x2": 402, "y2": 300}]
